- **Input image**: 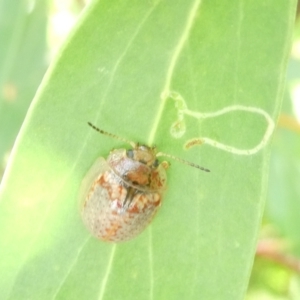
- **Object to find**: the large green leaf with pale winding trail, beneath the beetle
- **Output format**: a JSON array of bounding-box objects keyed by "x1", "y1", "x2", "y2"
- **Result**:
[{"x1": 0, "y1": 0, "x2": 295, "y2": 300}]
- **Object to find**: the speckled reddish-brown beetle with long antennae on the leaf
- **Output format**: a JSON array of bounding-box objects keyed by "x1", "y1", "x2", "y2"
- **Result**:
[{"x1": 81, "y1": 122, "x2": 209, "y2": 243}]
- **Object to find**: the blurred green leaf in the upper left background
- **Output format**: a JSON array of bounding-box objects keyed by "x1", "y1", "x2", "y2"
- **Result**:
[{"x1": 0, "y1": 0, "x2": 46, "y2": 179}]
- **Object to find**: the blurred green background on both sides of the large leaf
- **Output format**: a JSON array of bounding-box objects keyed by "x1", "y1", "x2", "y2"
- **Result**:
[{"x1": 0, "y1": 0, "x2": 300, "y2": 300}]
